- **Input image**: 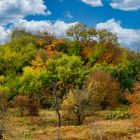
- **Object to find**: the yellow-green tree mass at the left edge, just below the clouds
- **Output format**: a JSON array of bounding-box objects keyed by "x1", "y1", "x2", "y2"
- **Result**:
[{"x1": 0, "y1": 30, "x2": 37, "y2": 74}]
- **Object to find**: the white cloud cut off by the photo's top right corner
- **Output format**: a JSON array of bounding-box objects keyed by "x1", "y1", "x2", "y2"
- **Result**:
[{"x1": 110, "y1": 0, "x2": 140, "y2": 11}]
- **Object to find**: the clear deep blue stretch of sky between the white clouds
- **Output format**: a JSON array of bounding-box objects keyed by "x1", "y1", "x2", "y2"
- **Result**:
[{"x1": 36, "y1": 0, "x2": 140, "y2": 29}]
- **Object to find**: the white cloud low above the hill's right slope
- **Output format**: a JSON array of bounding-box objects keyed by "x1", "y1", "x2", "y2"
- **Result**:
[{"x1": 96, "y1": 19, "x2": 140, "y2": 49}]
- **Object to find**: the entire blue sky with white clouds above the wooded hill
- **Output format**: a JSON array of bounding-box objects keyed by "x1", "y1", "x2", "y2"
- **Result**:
[{"x1": 0, "y1": 0, "x2": 140, "y2": 48}]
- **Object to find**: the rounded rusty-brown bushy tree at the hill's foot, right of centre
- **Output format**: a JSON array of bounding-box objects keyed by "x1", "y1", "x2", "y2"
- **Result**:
[{"x1": 86, "y1": 70, "x2": 120, "y2": 109}]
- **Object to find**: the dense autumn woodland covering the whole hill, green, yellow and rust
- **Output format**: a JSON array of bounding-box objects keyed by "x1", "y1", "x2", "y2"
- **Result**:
[{"x1": 0, "y1": 23, "x2": 140, "y2": 137}]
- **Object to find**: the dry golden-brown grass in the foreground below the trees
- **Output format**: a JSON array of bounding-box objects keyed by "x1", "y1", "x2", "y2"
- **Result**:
[{"x1": 2, "y1": 109, "x2": 140, "y2": 140}]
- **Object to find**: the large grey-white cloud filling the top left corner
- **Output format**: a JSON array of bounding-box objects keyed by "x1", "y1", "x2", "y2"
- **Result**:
[{"x1": 0, "y1": 0, "x2": 51, "y2": 24}]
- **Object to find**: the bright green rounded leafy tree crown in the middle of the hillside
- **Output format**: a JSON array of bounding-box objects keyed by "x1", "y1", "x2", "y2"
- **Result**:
[{"x1": 47, "y1": 54, "x2": 89, "y2": 87}]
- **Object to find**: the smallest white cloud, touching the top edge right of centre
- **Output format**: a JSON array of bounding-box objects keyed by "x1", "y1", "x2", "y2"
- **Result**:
[{"x1": 81, "y1": 0, "x2": 103, "y2": 7}]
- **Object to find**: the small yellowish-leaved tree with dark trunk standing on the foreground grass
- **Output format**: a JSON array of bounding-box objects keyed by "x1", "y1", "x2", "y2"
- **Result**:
[{"x1": 62, "y1": 89, "x2": 91, "y2": 125}]
